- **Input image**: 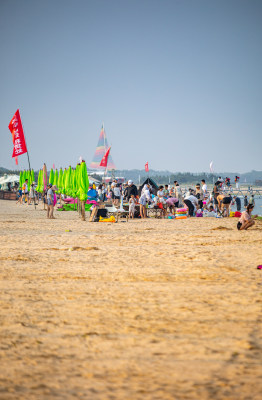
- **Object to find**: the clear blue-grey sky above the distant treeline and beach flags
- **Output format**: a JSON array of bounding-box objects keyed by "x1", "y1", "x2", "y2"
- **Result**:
[{"x1": 0, "y1": 0, "x2": 262, "y2": 172}]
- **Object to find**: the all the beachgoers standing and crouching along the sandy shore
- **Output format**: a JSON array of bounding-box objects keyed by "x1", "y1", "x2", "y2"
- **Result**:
[{"x1": 14, "y1": 177, "x2": 255, "y2": 230}]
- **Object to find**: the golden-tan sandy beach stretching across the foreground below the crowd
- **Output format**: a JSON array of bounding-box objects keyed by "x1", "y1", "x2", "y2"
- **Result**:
[{"x1": 0, "y1": 201, "x2": 262, "y2": 400}]
